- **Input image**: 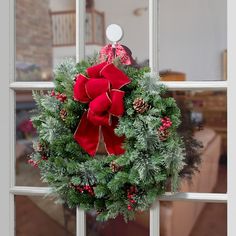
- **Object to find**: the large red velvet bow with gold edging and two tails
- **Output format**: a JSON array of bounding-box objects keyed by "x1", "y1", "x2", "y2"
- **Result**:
[{"x1": 74, "y1": 62, "x2": 130, "y2": 156}]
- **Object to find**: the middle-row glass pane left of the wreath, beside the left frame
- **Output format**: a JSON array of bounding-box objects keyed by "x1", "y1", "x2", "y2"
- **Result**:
[{"x1": 15, "y1": 91, "x2": 46, "y2": 186}]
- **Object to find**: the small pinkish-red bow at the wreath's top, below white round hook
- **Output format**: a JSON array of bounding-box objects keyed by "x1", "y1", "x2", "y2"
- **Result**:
[{"x1": 100, "y1": 43, "x2": 132, "y2": 65}]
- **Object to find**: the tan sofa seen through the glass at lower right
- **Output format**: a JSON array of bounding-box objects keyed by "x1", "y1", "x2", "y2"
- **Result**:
[{"x1": 136, "y1": 128, "x2": 221, "y2": 236}]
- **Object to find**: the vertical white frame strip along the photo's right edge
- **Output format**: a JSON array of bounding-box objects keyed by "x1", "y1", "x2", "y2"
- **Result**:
[{"x1": 227, "y1": 0, "x2": 236, "y2": 236}]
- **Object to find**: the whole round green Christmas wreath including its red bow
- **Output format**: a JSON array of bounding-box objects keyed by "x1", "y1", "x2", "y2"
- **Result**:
[{"x1": 29, "y1": 44, "x2": 196, "y2": 221}]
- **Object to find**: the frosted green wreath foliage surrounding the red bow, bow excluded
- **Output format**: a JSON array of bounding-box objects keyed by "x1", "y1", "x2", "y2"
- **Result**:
[{"x1": 30, "y1": 57, "x2": 186, "y2": 221}]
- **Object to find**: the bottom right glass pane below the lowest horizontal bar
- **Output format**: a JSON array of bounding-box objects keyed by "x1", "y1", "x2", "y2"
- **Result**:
[{"x1": 160, "y1": 201, "x2": 227, "y2": 236}]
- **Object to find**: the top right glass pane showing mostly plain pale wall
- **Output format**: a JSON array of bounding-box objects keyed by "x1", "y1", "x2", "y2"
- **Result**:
[{"x1": 159, "y1": 0, "x2": 227, "y2": 80}]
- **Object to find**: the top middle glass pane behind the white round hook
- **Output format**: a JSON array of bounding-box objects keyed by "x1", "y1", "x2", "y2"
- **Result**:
[{"x1": 86, "y1": 0, "x2": 149, "y2": 65}]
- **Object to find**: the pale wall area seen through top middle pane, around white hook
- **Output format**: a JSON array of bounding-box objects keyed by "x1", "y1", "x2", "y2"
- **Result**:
[{"x1": 95, "y1": 0, "x2": 148, "y2": 61}]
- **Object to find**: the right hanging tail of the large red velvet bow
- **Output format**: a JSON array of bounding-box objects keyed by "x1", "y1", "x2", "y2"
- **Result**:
[{"x1": 102, "y1": 119, "x2": 125, "y2": 155}]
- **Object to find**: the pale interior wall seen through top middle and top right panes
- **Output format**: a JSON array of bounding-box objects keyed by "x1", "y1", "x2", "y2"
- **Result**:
[{"x1": 95, "y1": 0, "x2": 226, "y2": 80}]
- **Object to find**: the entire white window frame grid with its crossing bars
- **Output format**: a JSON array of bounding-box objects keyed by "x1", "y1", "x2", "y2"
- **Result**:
[{"x1": 0, "y1": 0, "x2": 236, "y2": 236}]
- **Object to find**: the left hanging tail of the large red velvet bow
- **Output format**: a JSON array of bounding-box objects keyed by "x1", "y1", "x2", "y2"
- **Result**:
[{"x1": 74, "y1": 112, "x2": 100, "y2": 156}]
